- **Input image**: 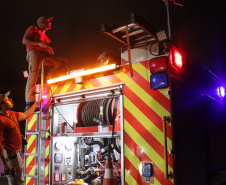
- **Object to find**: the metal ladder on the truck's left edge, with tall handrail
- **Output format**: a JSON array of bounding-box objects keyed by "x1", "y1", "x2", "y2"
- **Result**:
[{"x1": 24, "y1": 58, "x2": 50, "y2": 185}]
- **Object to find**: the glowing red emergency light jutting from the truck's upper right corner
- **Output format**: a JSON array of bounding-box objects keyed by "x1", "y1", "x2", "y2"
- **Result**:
[{"x1": 169, "y1": 46, "x2": 183, "y2": 69}]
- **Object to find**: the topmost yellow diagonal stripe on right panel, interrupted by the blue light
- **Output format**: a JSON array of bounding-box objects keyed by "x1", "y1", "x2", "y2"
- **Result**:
[{"x1": 133, "y1": 61, "x2": 170, "y2": 99}]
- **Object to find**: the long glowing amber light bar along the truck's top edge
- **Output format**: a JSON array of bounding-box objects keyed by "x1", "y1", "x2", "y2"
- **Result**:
[{"x1": 47, "y1": 64, "x2": 116, "y2": 84}]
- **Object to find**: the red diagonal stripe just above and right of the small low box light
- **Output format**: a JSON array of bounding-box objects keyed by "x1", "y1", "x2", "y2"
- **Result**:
[{"x1": 125, "y1": 133, "x2": 173, "y2": 185}]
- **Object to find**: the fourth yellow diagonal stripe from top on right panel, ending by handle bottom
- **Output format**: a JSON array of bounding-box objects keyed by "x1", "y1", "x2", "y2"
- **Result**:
[{"x1": 124, "y1": 120, "x2": 173, "y2": 177}]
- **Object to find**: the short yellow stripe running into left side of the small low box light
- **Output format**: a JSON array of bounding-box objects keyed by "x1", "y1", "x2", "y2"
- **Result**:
[{"x1": 124, "y1": 144, "x2": 161, "y2": 185}]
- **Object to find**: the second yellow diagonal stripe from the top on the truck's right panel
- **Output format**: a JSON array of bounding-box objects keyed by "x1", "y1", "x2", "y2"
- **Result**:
[{"x1": 126, "y1": 75, "x2": 170, "y2": 117}]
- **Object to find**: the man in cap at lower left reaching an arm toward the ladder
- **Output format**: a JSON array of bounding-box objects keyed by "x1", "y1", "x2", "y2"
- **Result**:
[{"x1": 0, "y1": 92, "x2": 41, "y2": 185}]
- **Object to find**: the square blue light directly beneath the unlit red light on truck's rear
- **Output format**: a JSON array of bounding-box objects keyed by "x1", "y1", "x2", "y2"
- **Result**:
[{"x1": 150, "y1": 73, "x2": 169, "y2": 90}]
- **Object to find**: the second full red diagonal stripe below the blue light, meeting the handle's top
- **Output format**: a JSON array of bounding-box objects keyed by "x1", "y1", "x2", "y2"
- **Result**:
[{"x1": 124, "y1": 86, "x2": 172, "y2": 140}]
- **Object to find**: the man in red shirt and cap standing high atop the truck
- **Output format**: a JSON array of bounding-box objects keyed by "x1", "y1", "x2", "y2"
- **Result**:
[{"x1": 22, "y1": 16, "x2": 68, "y2": 110}]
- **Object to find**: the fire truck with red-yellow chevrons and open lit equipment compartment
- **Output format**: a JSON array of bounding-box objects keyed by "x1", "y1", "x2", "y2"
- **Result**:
[{"x1": 25, "y1": 13, "x2": 226, "y2": 185}]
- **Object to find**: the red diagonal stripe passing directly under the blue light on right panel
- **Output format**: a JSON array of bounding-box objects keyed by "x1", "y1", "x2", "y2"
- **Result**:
[{"x1": 123, "y1": 65, "x2": 170, "y2": 112}]
